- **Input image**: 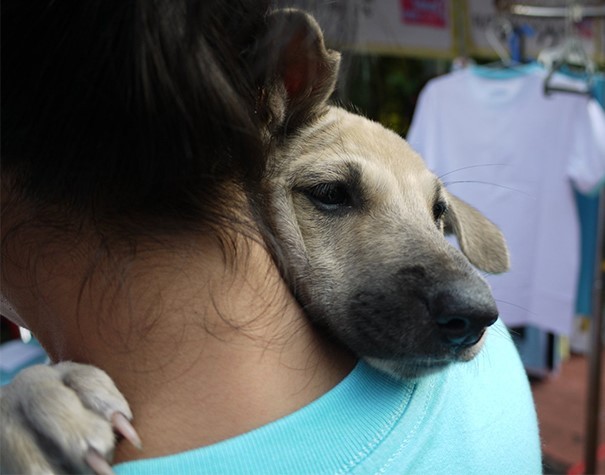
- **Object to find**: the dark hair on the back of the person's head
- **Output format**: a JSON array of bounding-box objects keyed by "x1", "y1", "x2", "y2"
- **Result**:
[{"x1": 2, "y1": 0, "x2": 269, "y2": 238}]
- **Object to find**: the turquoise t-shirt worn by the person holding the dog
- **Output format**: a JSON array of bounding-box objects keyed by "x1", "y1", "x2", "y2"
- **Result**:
[{"x1": 114, "y1": 322, "x2": 542, "y2": 475}]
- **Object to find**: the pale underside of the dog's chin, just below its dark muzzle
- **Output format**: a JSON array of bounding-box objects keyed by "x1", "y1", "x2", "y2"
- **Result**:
[{"x1": 364, "y1": 335, "x2": 485, "y2": 379}]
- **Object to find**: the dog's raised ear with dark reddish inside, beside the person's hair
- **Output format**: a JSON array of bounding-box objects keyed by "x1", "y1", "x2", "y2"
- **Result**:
[{"x1": 255, "y1": 9, "x2": 340, "y2": 136}]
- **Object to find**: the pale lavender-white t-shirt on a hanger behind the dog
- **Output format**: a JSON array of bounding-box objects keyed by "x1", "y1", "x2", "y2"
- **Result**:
[{"x1": 408, "y1": 67, "x2": 605, "y2": 335}]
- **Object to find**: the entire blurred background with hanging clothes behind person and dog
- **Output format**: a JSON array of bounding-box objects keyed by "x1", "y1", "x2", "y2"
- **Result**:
[{"x1": 0, "y1": 0, "x2": 605, "y2": 474}]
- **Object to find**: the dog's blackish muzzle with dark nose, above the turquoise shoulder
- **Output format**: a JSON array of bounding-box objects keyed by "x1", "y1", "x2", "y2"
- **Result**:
[{"x1": 336, "y1": 260, "x2": 498, "y2": 367}]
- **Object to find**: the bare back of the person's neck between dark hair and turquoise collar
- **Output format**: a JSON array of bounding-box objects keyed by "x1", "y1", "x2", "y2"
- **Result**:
[{"x1": 8, "y1": 232, "x2": 354, "y2": 462}]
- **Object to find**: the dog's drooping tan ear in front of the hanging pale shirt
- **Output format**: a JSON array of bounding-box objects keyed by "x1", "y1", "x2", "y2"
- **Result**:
[{"x1": 445, "y1": 193, "x2": 510, "y2": 274}]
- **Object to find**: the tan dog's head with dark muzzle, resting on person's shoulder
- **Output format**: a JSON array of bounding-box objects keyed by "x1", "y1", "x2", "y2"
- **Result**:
[{"x1": 252, "y1": 11, "x2": 508, "y2": 376}]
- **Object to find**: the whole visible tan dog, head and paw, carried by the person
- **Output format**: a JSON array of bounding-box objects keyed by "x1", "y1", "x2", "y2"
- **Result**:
[{"x1": 1, "y1": 10, "x2": 509, "y2": 472}]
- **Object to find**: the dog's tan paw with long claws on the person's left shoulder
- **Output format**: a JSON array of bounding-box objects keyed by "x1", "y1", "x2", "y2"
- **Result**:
[{"x1": 0, "y1": 362, "x2": 141, "y2": 474}]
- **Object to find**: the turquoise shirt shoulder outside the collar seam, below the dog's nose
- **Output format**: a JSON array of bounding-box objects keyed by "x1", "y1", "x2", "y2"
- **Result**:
[{"x1": 355, "y1": 322, "x2": 541, "y2": 474}]
